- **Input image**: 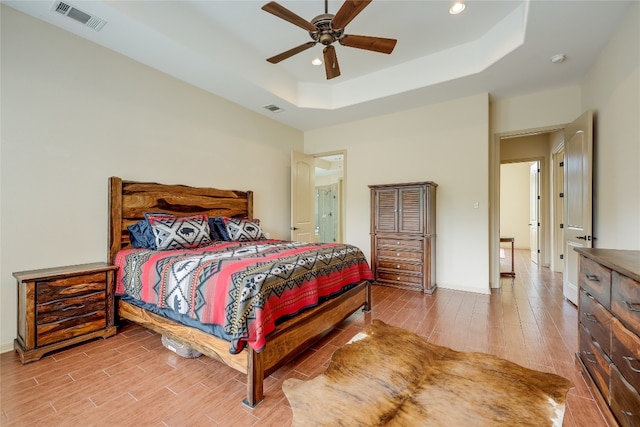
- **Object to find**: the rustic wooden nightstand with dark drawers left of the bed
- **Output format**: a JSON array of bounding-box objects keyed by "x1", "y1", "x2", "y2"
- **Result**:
[{"x1": 13, "y1": 262, "x2": 118, "y2": 363}]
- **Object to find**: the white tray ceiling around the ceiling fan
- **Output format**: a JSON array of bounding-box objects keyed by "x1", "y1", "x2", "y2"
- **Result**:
[{"x1": 2, "y1": 0, "x2": 633, "y2": 131}]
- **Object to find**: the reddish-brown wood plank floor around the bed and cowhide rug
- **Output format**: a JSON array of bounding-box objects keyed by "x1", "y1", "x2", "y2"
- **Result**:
[{"x1": 0, "y1": 251, "x2": 607, "y2": 427}]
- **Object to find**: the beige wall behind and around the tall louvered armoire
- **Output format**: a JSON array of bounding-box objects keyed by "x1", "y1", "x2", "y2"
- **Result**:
[{"x1": 305, "y1": 94, "x2": 489, "y2": 292}]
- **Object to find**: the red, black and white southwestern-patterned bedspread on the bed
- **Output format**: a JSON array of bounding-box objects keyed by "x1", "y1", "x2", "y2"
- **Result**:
[{"x1": 115, "y1": 240, "x2": 373, "y2": 353}]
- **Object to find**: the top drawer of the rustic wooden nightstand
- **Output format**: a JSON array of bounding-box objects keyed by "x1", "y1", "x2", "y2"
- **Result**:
[{"x1": 36, "y1": 273, "x2": 107, "y2": 304}]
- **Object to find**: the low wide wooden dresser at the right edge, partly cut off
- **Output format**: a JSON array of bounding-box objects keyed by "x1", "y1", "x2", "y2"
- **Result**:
[{"x1": 575, "y1": 248, "x2": 640, "y2": 427}]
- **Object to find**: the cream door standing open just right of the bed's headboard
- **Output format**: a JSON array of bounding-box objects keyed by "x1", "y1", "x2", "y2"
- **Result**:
[{"x1": 291, "y1": 151, "x2": 315, "y2": 242}]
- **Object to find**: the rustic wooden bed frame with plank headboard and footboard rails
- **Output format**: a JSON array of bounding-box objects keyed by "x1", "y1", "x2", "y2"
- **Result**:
[{"x1": 109, "y1": 177, "x2": 371, "y2": 408}]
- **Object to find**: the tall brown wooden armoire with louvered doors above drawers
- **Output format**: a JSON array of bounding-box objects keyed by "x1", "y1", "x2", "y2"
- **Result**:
[{"x1": 369, "y1": 181, "x2": 437, "y2": 294}]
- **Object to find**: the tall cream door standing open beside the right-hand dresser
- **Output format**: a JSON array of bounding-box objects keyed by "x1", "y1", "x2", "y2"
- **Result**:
[{"x1": 562, "y1": 111, "x2": 593, "y2": 305}]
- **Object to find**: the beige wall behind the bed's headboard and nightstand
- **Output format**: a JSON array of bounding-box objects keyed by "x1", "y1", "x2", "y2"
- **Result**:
[{"x1": 0, "y1": 6, "x2": 303, "y2": 350}]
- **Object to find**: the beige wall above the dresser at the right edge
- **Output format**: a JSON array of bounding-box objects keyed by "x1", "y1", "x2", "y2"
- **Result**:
[{"x1": 581, "y1": 2, "x2": 640, "y2": 249}]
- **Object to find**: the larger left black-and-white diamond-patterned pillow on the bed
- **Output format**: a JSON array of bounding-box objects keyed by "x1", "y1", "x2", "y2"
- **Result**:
[{"x1": 147, "y1": 215, "x2": 211, "y2": 250}]
